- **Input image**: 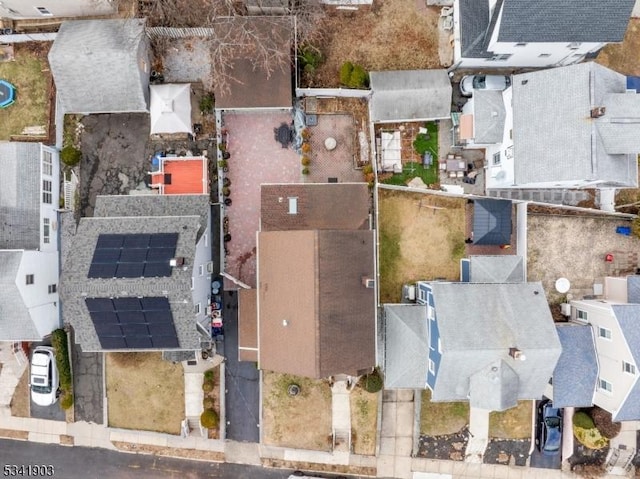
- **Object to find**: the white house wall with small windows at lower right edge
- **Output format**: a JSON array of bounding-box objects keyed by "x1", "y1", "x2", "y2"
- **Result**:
[{"x1": 571, "y1": 300, "x2": 638, "y2": 414}]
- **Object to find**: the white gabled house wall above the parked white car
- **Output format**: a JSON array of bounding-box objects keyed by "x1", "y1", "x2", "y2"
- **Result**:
[{"x1": 16, "y1": 251, "x2": 60, "y2": 336}]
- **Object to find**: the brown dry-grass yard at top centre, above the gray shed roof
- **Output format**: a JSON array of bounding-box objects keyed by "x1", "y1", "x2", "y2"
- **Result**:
[{"x1": 306, "y1": 0, "x2": 440, "y2": 87}]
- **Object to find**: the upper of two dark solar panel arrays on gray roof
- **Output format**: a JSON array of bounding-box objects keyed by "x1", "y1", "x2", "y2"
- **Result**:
[{"x1": 88, "y1": 233, "x2": 178, "y2": 278}]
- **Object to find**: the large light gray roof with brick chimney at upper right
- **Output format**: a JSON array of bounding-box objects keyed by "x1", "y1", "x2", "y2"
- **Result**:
[{"x1": 513, "y1": 62, "x2": 638, "y2": 186}]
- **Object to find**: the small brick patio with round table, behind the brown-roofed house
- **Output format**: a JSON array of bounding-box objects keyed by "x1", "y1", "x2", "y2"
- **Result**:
[{"x1": 305, "y1": 114, "x2": 364, "y2": 183}]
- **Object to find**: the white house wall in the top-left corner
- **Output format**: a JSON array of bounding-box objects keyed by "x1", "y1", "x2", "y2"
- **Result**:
[{"x1": 0, "y1": 0, "x2": 116, "y2": 20}]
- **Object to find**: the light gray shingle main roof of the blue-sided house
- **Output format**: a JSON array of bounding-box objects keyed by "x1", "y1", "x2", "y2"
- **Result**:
[{"x1": 431, "y1": 282, "x2": 561, "y2": 406}]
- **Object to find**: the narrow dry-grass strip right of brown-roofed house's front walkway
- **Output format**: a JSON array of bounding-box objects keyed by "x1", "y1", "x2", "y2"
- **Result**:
[{"x1": 349, "y1": 387, "x2": 378, "y2": 456}]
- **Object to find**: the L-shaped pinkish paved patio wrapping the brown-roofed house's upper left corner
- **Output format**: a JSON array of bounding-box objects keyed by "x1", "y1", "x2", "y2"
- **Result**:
[{"x1": 223, "y1": 112, "x2": 301, "y2": 289}]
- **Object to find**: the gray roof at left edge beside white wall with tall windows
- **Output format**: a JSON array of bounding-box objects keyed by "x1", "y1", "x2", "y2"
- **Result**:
[{"x1": 0, "y1": 142, "x2": 41, "y2": 250}]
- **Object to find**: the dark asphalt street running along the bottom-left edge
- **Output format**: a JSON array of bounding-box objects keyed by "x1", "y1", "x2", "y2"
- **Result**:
[{"x1": 0, "y1": 439, "x2": 357, "y2": 479}]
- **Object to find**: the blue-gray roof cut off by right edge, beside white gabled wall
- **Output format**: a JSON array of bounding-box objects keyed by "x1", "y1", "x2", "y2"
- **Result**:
[{"x1": 611, "y1": 304, "x2": 640, "y2": 421}]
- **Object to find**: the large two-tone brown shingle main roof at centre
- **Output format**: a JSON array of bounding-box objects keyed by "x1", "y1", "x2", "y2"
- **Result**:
[{"x1": 258, "y1": 230, "x2": 376, "y2": 378}]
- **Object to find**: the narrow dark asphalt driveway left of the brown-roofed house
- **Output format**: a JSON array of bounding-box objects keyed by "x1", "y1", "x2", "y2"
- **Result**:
[{"x1": 223, "y1": 291, "x2": 260, "y2": 442}]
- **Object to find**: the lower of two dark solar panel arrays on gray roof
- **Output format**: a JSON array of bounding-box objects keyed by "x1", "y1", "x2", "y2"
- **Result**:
[{"x1": 85, "y1": 297, "x2": 178, "y2": 349}]
